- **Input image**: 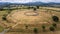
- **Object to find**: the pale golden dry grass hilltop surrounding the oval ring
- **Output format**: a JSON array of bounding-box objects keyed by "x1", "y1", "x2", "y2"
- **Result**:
[{"x1": 8, "y1": 10, "x2": 51, "y2": 24}]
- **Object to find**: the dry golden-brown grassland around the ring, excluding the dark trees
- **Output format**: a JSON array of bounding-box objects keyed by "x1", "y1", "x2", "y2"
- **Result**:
[{"x1": 0, "y1": 7, "x2": 60, "y2": 34}]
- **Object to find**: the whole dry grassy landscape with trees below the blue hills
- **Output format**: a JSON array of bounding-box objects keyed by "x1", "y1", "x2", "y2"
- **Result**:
[{"x1": 0, "y1": 6, "x2": 60, "y2": 34}]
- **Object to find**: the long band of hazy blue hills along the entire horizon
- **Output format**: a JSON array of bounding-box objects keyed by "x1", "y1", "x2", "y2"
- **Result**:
[{"x1": 0, "y1": 2, "x2": 60, "y2": 8}]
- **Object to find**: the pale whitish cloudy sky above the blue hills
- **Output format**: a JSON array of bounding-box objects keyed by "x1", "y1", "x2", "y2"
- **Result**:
[{"x1": 0, "y1": 0, "x2": 60, "y2": 3}]
